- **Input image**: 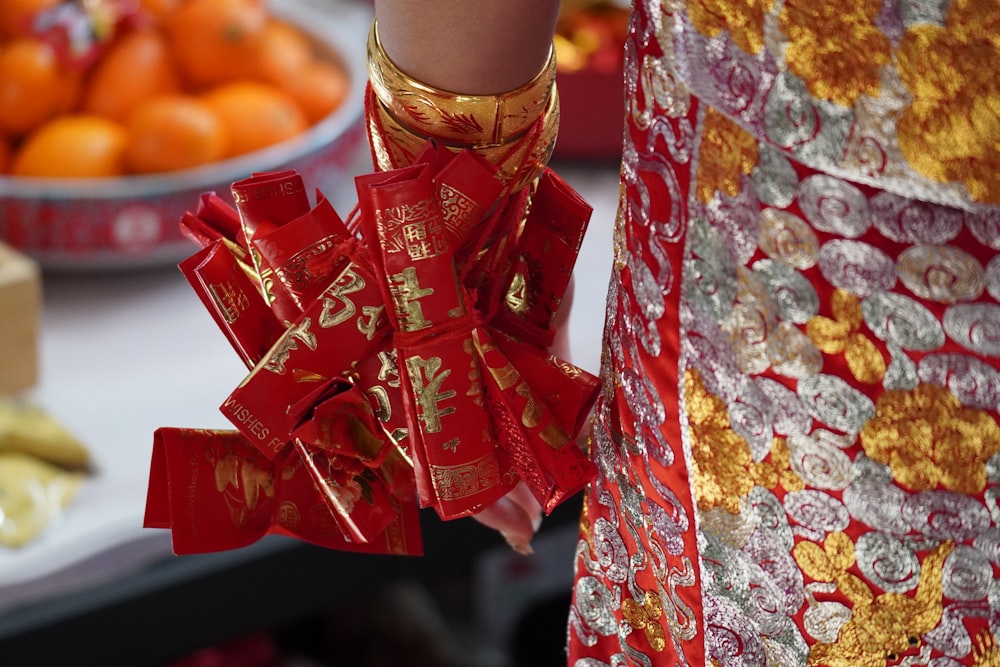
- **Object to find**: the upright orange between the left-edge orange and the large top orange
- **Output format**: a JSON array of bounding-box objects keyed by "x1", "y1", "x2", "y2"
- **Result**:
[{"x1": 83, "y1": 28, "x2": 181, "y2": 122}]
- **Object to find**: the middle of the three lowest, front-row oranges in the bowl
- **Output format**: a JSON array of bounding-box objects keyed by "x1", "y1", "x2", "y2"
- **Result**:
[{"x1": 125, "y1": 95, "x2": 226, "y2": 173}]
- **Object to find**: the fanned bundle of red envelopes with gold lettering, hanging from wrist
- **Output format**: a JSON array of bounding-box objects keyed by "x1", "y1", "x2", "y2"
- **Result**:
[{"x1": 145, "y1": 143, "x2": 597, "y2": 554}]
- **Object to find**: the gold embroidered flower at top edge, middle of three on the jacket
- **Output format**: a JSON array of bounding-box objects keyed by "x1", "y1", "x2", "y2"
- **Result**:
[{"x1": 778, "y1": 0, "x2": 892, "y2": 106}]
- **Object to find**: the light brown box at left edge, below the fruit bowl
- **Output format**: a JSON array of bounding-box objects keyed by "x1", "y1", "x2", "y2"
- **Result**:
[{"x1": 0, "y1": 243, "x2": 42, "y2": 395}]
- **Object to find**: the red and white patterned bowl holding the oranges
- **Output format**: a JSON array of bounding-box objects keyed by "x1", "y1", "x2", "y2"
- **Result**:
[{"x1": 0, "y1": 0, "x2": 371, "y2": 270}]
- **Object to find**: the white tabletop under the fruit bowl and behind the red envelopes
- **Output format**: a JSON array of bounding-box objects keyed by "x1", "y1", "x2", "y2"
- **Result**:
[{"x1": 0, "y1": 151, "x2": 618, "y2": 640}]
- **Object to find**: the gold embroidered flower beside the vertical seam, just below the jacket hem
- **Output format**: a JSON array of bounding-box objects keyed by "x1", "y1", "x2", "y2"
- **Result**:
[{"x1": 696, "y1": 107, "x2": 758, "y2": 204}]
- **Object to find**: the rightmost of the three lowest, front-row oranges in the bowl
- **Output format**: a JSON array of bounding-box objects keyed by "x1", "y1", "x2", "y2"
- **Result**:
[{"x1": 202, "y1": 81, "x2": 309, "y2": 157}]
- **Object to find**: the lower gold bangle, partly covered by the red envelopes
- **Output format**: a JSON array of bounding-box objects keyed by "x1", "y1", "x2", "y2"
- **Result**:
[{"x1": 366, "y1": 86, "x2": 559, "y2": 192}]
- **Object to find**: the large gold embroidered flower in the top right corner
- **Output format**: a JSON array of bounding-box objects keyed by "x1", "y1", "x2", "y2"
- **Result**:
[{"x1": 897, "y1": 0, "x2": 1000, "y2": 204}]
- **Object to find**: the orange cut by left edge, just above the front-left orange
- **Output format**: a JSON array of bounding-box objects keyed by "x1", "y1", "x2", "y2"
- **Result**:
[{"x1": 0, "y1": 38, "x2": 79, "y2": 134}]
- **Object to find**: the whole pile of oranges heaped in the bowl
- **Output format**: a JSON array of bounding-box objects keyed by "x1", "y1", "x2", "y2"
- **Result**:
[{"x1": 0, "y1": 0, "x2": 348, "y2": 178}]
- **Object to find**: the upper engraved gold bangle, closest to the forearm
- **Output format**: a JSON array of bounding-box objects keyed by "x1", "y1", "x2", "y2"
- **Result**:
[{"x1": 368, "y1": 21, "x2": 556, "y2": 147}]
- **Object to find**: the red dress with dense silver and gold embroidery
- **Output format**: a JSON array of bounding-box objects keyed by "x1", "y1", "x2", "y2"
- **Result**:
[{"x1": 569, "y1": 0, "x2": 1000, "y2": 667}]
